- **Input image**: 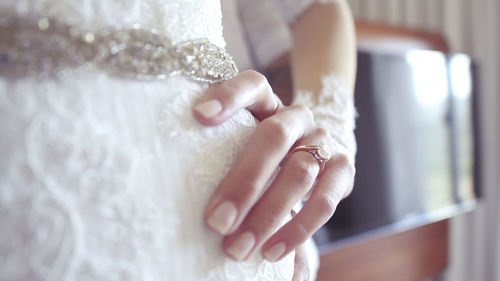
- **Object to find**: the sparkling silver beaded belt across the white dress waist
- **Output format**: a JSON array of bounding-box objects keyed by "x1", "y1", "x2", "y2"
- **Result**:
[{"x1": 0, "y1": 13, "x2": 238, "y2": 83}]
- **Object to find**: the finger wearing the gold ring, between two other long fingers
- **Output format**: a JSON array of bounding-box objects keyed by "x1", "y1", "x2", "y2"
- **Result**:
[{"x1": 219, "y1": 129, "x2": 330, "y2": 260}]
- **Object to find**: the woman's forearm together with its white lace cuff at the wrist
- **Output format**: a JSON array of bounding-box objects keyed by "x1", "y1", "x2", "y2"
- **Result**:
[{"x1": 291, "y1": 1, "x2": 357, "y2": 197}]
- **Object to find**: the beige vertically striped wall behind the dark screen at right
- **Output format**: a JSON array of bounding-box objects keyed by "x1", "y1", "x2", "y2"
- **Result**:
[{"x1": 348, "y1": 0, "x2": 500, "y2": 281}]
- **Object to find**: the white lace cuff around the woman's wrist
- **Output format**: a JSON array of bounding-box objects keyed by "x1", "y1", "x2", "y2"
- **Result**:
[{"x1": 293, "y1": 74, "x2": 357, "y2": 164}]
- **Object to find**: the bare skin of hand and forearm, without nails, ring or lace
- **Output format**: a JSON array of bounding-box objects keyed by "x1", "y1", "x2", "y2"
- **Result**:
[{"x1": 193, "y1": 2, "x2": 356, "y2": 280}]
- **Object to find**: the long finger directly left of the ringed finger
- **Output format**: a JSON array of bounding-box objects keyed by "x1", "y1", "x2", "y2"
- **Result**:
[{"x1": 205, "y1": 106, "x2": 313, "y2": 236}]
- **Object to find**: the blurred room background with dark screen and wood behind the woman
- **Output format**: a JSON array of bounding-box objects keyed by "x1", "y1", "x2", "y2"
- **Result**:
[{"x1": 222, "y1": 0, "x2": 500, "y2": 281}]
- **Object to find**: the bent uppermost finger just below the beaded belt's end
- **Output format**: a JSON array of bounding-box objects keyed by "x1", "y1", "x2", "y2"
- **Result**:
[{"x1": 193, "y1": 70, "x2": 282, "y2": 126}]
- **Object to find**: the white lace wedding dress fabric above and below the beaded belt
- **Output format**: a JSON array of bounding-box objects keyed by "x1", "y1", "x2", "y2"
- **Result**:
[{"x1": 0, "y1": 0, "x2": 294, "y2": 281}]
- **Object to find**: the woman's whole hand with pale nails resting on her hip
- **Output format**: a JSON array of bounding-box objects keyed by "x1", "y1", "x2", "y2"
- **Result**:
[{"x1": 193, "y1": 71, "x2": 354, "y2": 261}]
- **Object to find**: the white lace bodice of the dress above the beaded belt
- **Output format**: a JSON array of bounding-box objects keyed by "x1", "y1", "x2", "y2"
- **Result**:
[{"x1": 0, "y1": 0, "x2": 225, "y2": 47}]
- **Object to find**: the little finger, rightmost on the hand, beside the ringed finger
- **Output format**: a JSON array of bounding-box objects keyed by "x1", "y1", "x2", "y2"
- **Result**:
[{"x1": 262, "y1": 154, "x2": 354, "y2": 261}]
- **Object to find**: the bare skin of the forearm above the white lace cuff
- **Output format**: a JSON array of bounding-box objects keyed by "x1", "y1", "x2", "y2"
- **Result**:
[{"x1": 291, "y1": 1, "x2": 356, "y2": 94}]
